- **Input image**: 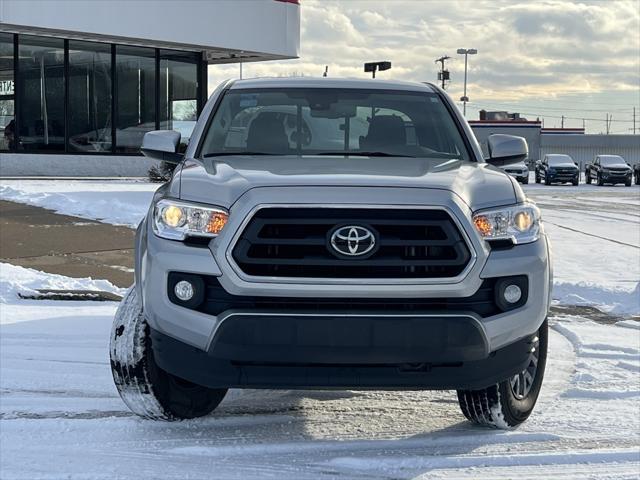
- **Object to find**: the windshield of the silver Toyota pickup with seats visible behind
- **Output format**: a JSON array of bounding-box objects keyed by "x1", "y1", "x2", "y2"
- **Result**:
[{"x1": 201, "y1": 88, "x2": 469, "y2": 160}]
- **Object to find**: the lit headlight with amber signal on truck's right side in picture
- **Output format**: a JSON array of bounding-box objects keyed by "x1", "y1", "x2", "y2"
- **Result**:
[{"x1": 473, "y1": 202, "x2": 541, "y2": 244}]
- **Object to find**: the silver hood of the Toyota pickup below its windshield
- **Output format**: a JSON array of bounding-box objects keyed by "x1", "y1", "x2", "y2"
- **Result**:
[{"x1": 173, "y1": 156, "x2": 522, "y2": 210}]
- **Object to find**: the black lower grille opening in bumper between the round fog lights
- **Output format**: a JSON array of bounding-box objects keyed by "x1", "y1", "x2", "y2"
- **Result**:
[{"x1": 195, "y1": 273, "x2": 502, "y2": 317}]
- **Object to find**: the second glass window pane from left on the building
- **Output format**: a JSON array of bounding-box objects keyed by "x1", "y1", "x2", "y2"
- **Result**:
[{"x1": 16, "y1": 35, "x2": 65, "y2": 151}]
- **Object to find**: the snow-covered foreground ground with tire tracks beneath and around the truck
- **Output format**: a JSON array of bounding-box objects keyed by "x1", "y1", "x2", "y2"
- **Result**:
[{"x1": 0, "y1": 265, "x2": 640, "y2": 480}]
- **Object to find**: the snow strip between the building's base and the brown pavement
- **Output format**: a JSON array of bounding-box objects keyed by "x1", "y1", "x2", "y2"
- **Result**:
[{"x1": 0, "y1": 180, "x2": 159, "y2": 228}]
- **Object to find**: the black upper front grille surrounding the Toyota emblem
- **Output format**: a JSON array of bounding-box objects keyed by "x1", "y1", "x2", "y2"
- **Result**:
[{"x1": 232, "y1": 208, "x2": 471, "y2": 278}]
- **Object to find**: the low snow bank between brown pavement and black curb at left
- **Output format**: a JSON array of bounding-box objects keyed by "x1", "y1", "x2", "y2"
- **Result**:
[{"x1": 0, "y1": 263, "x2": 126, "y2": 310}]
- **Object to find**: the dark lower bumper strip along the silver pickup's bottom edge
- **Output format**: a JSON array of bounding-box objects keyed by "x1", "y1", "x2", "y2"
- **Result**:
[{"x1": 151, "y1": 329, "x2": 531, "y2": 390}]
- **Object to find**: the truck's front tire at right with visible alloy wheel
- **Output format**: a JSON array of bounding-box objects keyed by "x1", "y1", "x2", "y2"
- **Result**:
[{"x1": 458, "y1": 320, "x2": 549, "y2": 429}]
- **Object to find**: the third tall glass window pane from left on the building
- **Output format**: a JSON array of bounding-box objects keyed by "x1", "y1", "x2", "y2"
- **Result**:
[{"x1": 67, "y1": 40, "x2": 113, "y2": 153}]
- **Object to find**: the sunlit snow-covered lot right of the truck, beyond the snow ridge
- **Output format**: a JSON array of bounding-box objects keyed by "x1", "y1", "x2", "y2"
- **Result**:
[{"x1": 524, "y1": 184, "x2": 640, "y2": 314}]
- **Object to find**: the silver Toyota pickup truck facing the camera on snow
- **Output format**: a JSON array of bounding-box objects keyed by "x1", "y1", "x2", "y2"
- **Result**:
[{"x1": 110, "y1": 78, "x2": 552, "y2": 428}]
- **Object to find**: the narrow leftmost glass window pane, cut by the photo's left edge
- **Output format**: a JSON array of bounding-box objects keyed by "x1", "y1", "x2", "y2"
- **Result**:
[{"x1": 0, "y1": 33, "x2": 16, "y2": 152}]
